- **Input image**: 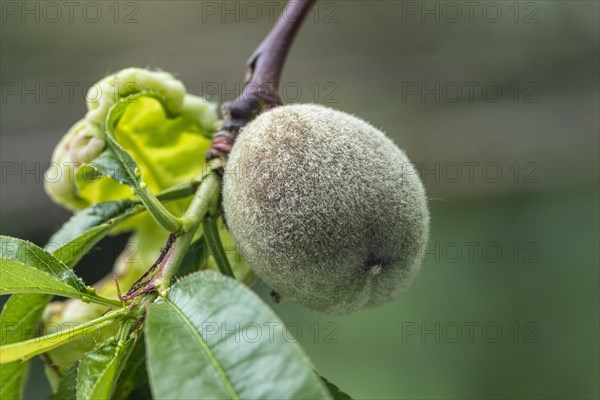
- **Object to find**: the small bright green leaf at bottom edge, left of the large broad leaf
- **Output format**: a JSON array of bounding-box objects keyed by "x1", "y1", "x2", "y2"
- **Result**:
[{"x1": 77, "y1": 339, "x2": 135, "y2": 400}]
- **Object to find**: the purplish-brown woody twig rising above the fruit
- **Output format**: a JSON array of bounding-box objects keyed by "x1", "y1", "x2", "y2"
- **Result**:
[{"x1": 206, "y1": 0, "x2": 315, "y2": 160}]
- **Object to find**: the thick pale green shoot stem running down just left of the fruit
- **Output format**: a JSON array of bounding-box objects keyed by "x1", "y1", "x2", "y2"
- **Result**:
[{"x1": 155, "y1": 172, "x2": 221, "y2": 292}]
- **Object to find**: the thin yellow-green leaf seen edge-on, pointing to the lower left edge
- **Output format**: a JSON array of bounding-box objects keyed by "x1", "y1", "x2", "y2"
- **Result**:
[{"x1": 0, "y1": 310, "x2": 124, "y2": 364}]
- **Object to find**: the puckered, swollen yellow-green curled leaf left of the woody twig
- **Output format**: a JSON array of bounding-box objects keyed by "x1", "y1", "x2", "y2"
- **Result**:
[{"x1": 45, "y1": 68, "x2": 218, "y2": 219}]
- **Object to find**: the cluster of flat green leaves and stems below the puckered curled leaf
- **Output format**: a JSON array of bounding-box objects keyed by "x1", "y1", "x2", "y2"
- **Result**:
[{"x1": 0, "y1": 92, "x2": 349, "y2": 399}]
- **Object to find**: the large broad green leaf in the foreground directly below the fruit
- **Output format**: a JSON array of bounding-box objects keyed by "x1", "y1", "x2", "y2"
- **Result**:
[{"x1": 146, "y1": 271, "x2": 331, "y2": 399}]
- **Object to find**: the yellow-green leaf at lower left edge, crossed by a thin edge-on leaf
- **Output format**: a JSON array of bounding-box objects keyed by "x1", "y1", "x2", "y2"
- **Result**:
[{"x1": 0, "y1": 294, "x2": 50, "y2": 399}]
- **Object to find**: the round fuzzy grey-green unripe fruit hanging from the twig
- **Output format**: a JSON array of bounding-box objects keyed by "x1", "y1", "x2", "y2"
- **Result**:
[{"x1": 223, "y1": 104, "x2": 429, "y2": 314}]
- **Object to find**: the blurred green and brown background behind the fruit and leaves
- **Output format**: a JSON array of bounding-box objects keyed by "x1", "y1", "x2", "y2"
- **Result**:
[{"x1": 0, "y1": 0, "x2": 600, "y2": 399}]
